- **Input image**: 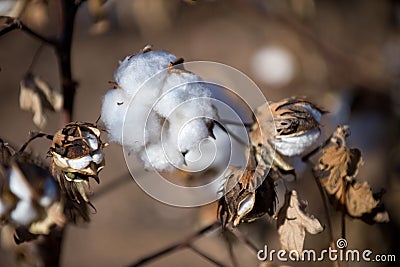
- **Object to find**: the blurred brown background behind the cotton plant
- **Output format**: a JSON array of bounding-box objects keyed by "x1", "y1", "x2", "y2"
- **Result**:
[{"x1": 0, "y1": 0, "x2": 400, "y2": 266}]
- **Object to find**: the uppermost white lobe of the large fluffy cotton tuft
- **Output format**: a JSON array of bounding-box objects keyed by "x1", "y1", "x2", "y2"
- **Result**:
[{"x1": 114, "y1": 51, "x2": 176, "y2": 95}]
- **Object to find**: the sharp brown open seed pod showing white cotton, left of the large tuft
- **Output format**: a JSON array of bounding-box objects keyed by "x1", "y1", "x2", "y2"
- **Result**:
[{"x1": 49, "y1": 122, "x2": 106, "y2": 205}]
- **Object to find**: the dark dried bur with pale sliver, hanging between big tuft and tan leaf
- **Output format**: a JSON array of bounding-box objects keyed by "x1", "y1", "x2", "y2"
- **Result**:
[{"x1": 219, "y1": 154, "x2": 276, "y2": 227}]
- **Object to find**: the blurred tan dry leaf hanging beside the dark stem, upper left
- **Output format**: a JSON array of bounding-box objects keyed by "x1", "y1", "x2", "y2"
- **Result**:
[{"x1": 19, "y1": 73, "x2": 63, "y2": 128}]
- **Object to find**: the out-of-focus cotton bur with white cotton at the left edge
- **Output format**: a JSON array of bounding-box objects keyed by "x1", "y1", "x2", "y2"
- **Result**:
[{"x1": 0, "y1": 140, "x2": 66, "y2": 244}]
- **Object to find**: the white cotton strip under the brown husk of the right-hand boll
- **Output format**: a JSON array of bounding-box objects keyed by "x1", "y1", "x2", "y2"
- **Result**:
[{"x1": 273, "y1": 128, "x2": 320, "y2": 157}]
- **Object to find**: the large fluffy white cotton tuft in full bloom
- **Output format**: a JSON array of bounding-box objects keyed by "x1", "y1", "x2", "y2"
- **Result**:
[{"x1": 101, "y1": 51, "x2": 217, "y2": 171}]
